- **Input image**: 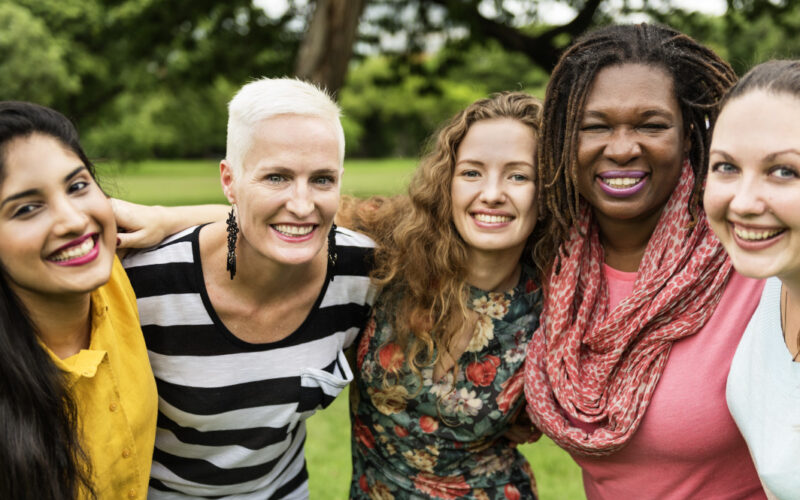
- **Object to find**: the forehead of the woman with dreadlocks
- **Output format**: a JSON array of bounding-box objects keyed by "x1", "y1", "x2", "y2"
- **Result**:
[{"x1": 585, "y1": 63, "x2": 680, "y2": 114}]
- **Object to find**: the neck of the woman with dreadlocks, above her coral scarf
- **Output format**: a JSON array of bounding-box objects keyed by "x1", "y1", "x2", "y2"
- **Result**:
[{"x1": 595, "y1": 207, "x2": 661, "y2": 272}]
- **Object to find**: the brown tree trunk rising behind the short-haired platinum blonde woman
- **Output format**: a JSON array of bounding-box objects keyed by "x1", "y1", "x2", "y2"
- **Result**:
[{"x1": 295, "y1": 0, "x2": 367, "y2": 95}]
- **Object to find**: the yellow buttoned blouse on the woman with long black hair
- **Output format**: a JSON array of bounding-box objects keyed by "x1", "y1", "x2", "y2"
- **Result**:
[{"x1": 48, "y1": 258, "x2": 158, "y2": 500}]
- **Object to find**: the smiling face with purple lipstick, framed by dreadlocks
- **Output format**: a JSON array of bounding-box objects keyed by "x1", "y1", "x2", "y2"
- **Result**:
[{"x1": 578, "y1": 63, "x2": 689, "y2": 227}]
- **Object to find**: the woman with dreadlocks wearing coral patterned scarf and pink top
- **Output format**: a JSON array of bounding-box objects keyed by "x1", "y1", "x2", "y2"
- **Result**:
[{"x1": 525, "y1": 24, "x2": 764, "y2": 499}]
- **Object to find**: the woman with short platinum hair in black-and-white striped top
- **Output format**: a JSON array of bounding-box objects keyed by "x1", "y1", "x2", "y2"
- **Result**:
[{"x1": 123, "y1": 78, "x2": 373, "y2": 499}]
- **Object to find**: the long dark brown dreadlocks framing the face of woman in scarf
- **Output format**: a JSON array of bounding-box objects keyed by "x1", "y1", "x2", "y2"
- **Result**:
[{"x1": 534, "y1": 23, "x2": 736, "y2": 274}]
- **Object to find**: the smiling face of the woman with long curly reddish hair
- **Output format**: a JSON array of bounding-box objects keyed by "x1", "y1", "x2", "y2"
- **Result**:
[{"x1": 451, "y1": 118, "x2": 537, "y2": 259}]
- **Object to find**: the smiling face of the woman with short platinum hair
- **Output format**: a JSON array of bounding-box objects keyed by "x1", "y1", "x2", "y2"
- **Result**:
[{"x1": 220, "y1": 115, "x2": 342, "y2": 265}]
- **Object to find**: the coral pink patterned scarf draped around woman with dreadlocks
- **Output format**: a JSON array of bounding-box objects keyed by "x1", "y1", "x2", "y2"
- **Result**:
[{"x1": 525, "y1": 162, "x2": 731, "y2": 455}]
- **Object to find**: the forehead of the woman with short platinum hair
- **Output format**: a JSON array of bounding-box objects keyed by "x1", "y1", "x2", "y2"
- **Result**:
[{"x1": 244, "y1": 114, "x2": 341, "y2": 174}]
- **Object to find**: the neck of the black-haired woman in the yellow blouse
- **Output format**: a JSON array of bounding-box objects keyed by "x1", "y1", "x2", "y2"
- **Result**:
[{"x1": 14, "y1": 289, "x2": 92, "y2": 359}]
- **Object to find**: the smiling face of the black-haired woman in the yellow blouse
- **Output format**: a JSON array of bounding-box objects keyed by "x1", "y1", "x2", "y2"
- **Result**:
[{"x1": 0, "y1": 134, "x2": 116, "y2": 301}]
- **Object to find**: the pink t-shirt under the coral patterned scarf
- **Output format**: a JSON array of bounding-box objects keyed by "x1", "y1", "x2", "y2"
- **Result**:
[{"x1": 573, "y1": 266, "x2": 766, "y2": 500}]
